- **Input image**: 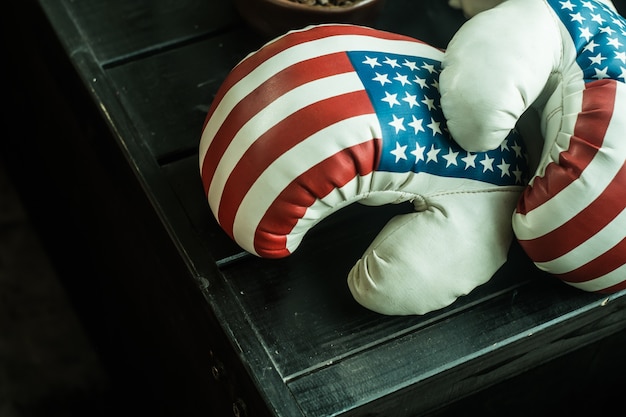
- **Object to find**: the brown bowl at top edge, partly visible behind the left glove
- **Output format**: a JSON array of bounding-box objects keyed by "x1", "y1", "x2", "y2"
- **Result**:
[{"x1": 235, "y1": 0, "x2": 384, "y2": 37}]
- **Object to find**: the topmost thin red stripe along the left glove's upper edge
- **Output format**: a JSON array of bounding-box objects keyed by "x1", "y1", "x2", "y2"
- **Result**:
[{"x1": 204, "y1": 25, "x2": 425, "y2": 132}]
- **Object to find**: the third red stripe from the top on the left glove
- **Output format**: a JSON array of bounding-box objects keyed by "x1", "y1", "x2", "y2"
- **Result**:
[{"x1": 218, "y1": 90, "x2": 374, "y2": 236}]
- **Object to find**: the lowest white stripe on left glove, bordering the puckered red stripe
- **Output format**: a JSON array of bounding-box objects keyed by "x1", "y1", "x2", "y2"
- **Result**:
[{"x1": 233, "y1": 114, "x2": 382, "y2": 253}]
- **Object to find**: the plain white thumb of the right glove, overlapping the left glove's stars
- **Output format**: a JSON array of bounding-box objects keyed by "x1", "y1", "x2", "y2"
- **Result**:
[{"x1": 439, "y1": 0, "x2": 562, "y2": 151}]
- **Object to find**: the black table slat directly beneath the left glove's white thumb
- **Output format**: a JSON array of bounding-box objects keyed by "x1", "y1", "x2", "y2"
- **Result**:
[{"x1": 218, "y1": 242, "x2": 525, "y2": 383}]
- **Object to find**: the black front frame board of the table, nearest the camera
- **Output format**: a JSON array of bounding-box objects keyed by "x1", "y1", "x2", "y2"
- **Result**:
[{"x1": 288, "y1": 281, "x2": 626, "y2": 417}]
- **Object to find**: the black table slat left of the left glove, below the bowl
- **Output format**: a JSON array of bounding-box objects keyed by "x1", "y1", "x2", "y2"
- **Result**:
[{"x1": 107, "y1": 29, "x2": 260, "y2": 163}]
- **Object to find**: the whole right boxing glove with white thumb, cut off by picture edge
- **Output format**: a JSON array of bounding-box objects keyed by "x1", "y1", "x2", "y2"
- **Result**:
[{"x1": 440, "y1": 0, "x2": 626, "y2": 293}]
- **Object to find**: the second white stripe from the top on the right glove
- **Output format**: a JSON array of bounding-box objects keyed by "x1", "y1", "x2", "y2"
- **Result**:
[{"x1": 536, "y1": 206, "x2": 626, "y2": 272}]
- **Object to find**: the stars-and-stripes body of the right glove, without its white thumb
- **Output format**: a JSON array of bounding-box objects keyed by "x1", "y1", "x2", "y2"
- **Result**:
[{"x1": 513, "y1": 0, "x2": 626, "y2": 293}]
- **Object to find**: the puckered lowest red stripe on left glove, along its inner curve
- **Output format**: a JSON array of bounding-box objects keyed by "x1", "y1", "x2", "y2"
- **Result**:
[{"x1": 254, "y1": 139, "x2": 382, "y2": 258}]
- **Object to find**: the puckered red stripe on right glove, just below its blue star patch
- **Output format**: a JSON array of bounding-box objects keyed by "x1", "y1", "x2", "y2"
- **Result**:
[{"x1": 517, "y1": 80, "x2": 616, "y2": 214}]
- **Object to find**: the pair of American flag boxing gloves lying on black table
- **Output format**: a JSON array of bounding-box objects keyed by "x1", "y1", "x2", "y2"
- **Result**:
[{"x1": 199, "y1": 0, "x2": 626, "y2": 315}]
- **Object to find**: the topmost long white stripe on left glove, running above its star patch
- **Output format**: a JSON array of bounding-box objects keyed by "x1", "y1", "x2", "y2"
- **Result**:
[{"x1": 199, "y1": 35, "x2": 443, "y2": 171}]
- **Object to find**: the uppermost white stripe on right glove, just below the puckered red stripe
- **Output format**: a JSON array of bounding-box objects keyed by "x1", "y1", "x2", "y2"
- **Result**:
[{"x1": 513, "y1": 84, "x2": 626, "y2": 240}]
